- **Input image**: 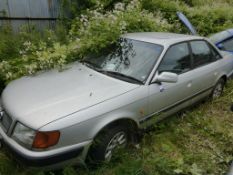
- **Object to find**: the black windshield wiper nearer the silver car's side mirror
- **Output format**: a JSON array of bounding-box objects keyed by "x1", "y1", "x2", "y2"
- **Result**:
[{"x1": 98, "y1": 70, "x2": 143, "y2": 84}]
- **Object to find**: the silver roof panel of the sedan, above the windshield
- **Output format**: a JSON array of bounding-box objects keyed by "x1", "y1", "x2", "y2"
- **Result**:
[{"x1": 123, "y1": 32, "x2": 203, "y2": 45}]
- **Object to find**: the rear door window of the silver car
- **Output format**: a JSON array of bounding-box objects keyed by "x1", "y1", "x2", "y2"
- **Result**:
[{"x1": 190, "y1": 41, "x2": 213, "y2": 67}]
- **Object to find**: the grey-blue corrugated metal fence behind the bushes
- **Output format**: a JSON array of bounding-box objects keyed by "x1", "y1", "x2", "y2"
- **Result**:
[{"x1": 0, "y1": 0, "x2": 61, "y2": 31}]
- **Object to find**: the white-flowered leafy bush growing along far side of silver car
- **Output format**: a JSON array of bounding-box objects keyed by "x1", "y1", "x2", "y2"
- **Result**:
[{"x1": 0, "y1": 0, "x2": 172, "y2": 82}]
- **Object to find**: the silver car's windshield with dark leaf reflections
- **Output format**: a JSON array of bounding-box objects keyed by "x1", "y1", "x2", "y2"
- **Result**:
[{"x1": 83, "y1": 38, "x2": 163, "y2": 82}]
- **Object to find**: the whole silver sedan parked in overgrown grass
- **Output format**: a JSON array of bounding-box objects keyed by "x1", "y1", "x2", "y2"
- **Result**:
[{"x1": 0, "y1": 33, "x2": 233, "y2": 166}]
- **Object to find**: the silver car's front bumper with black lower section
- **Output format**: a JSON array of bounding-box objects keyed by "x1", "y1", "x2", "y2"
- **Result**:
[{"x1": 0, "y1": 127, "x2": 91, "y2": 167}]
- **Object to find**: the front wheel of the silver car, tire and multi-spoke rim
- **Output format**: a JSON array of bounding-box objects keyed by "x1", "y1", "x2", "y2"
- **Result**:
[{"x1": 88, "y1": 125, "x2": 129, "y2": 165}]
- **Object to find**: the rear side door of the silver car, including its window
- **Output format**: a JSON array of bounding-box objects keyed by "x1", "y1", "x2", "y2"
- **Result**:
[{"x1": 187, "y1": 40, "x2": 221, "y2": 100}]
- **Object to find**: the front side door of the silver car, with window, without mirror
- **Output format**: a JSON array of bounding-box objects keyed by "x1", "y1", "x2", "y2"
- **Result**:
[{"x1": 141, "y1": 42, "x2": 191, "y2": 123}]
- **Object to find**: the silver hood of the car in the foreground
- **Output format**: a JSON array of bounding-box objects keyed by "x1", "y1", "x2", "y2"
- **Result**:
[{"x1": 2, "y1": 63, "x2": 139, "y2": 129}]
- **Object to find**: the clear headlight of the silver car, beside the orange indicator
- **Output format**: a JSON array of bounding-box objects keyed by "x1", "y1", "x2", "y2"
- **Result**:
[{"x1": 12, "y1": 122, "x2": 36, "y2": 148}]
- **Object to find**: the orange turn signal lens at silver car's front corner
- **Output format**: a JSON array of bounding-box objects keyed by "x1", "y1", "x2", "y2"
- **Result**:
[{"x1": 32, "y1": 131, "x2": 60, "y2": 149}]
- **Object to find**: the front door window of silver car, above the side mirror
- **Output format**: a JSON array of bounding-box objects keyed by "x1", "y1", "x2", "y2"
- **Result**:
[{"x1": 158, "y1": 43, "x2": 191, "y2": 74}]
